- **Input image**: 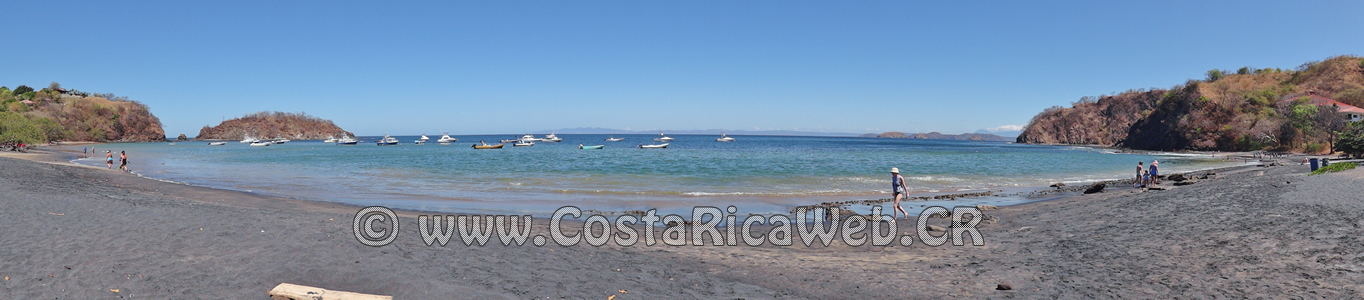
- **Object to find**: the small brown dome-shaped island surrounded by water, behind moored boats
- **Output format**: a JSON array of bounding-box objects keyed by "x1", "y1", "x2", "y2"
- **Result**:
[{"x1": 194, "y1": 112, "x2": 355, "y2": 139}]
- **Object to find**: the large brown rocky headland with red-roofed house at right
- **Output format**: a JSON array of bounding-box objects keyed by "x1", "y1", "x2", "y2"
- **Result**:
[{"x1": 1016, "y1": 56, "x2": 1364, "y2": 153}]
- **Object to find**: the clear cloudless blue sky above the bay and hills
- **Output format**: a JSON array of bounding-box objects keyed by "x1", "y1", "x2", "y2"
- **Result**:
[{"x1": 0, "y1": 1, "x2": 1364, "y2": 136}]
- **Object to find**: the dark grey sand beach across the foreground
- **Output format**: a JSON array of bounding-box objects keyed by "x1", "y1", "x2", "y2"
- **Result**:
[{"x1": 0, "y1": 148, "x2": 1364, "y2": 299}]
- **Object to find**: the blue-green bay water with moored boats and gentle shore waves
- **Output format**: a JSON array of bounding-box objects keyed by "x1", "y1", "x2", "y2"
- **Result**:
[{"x1": 75, "y1": 135, "x2": 1228, "y2": 214}]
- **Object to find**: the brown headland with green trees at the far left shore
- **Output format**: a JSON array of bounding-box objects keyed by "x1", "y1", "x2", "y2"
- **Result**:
[{"x1": 0, "y1": 82, "x2": 166, "y2": 146}]
